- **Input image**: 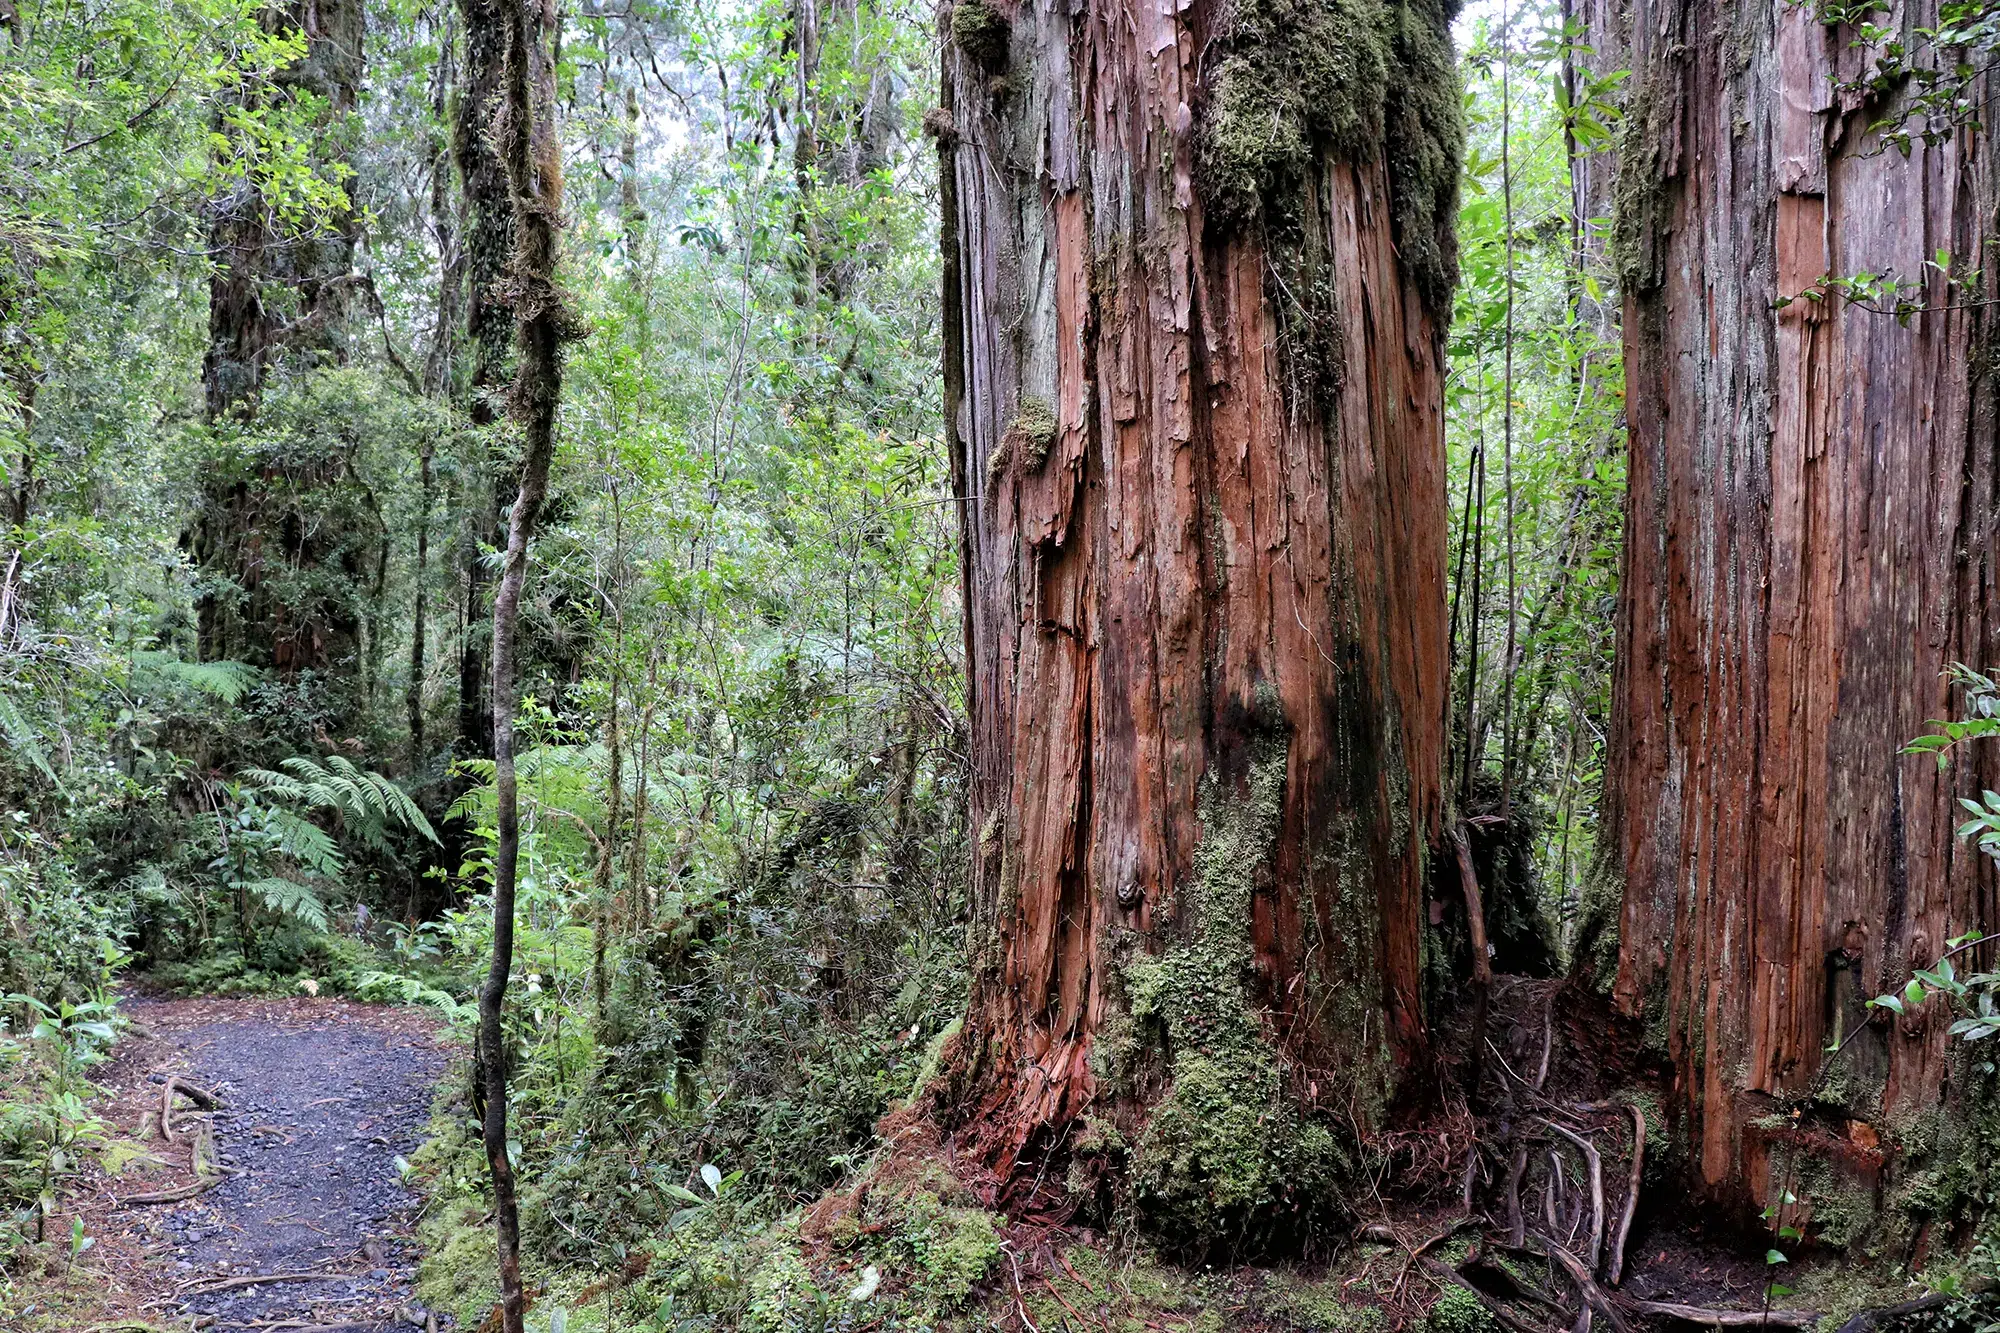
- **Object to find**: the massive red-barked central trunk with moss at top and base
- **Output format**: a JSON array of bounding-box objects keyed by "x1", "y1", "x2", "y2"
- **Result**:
[{"x1": 930, "y1": 0, "x2": 1460, "y2": 1243}]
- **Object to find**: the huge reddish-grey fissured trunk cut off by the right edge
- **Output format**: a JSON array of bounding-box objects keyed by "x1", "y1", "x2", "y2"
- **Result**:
[{"x1": 1584, "y1": 0, "x2": 2000, "y2": 1243}]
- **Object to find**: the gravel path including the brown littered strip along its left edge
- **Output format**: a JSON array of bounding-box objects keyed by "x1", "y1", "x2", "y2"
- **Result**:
[{"x1": 11, "y1": 995, "x2": 450, "y2": 1333}]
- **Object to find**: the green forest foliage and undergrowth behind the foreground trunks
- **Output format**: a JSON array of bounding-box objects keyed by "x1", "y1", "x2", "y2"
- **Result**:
[{"x1": 0, "y1": 0, "x2": 1970, "y2": 1333}]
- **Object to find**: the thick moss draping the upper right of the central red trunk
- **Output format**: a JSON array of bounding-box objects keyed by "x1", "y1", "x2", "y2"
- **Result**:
[{"x1": 1198, "y1": 0, "x2": 1464, "y2": 314}]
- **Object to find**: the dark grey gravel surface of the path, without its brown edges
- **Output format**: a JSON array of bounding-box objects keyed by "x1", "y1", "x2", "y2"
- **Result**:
[{"x1": 104, "y1": 999, "x2": 450, "y2": 1333}]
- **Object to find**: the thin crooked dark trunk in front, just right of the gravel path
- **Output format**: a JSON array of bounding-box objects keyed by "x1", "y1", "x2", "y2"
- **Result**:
[{"x1": 480, "y1": 0, "x2": 574, "y2": 1333}]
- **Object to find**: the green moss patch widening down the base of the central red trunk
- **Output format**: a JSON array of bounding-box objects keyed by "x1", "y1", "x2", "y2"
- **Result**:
[{"x1": 1126, "y1": 699, "x2": 1352, "y2": 1247}]
